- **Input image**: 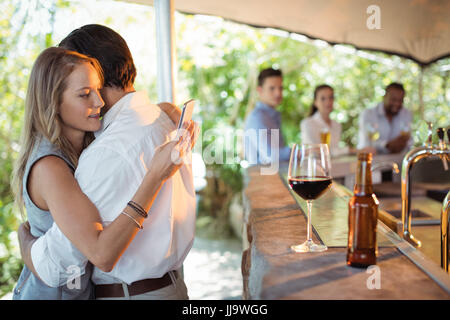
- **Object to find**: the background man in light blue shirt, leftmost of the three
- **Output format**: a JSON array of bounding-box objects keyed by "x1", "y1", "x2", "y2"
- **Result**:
[{"x1": 244, "y1": 68, "x2": 290, "y2": 170}]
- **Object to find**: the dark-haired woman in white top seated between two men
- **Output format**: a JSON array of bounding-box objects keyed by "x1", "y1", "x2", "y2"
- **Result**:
[{"x1": 300, "y1": 84, "x2": 351, "y2": 156}]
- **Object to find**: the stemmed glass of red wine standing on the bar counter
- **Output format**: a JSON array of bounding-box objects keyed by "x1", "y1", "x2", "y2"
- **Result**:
[{"x1": 288, "y1": 144, "x2": 332, "y2": 252}]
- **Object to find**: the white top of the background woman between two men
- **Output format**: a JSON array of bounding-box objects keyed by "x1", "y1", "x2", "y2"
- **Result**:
[{"x1": 300, "y1": 111, "x2": 349, "y2": 156}]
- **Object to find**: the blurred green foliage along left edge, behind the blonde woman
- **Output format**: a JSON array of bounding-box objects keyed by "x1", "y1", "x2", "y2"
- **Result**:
[{"x1": 0, "y1": 0, "x2": 67, "y2": 296}]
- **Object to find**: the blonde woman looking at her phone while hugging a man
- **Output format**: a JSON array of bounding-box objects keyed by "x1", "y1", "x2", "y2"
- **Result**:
[{"x1": 13, "y1": 48, "x2": 194, "y2": 299}]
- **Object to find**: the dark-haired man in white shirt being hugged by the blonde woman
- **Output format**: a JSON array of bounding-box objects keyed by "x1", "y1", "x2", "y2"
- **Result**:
[{"x1": 18, "y1": 25, "x2": 196, "y2": 299}]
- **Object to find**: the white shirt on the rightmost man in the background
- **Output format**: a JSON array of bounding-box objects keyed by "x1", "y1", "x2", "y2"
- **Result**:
[{"x1": 358, "y1": 102, "x2": 413, "y2": 153}]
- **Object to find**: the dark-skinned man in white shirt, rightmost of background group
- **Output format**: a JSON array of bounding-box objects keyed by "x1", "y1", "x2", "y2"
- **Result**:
[{"x1": 358, "y1": 82, "x2": 413, "y2": 153}]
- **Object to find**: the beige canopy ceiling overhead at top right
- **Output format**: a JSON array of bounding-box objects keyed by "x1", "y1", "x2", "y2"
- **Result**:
[{"x1": 125, "y1": 0, "x2": 450, "y2": 65}]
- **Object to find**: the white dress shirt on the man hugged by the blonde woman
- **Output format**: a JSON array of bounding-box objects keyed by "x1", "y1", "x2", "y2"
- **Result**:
[{"x1": 31, "y1": 92, "x2": 196, "y2": 286}]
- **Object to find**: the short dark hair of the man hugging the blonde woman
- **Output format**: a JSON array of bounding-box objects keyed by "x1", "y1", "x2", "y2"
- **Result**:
[{"x1": 59, "y1": 24, "x2": 136, "y2": 89}]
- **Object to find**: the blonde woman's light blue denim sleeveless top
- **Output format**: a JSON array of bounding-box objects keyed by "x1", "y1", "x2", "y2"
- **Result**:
[{"x1": 13, "y1": 138, "x2": 93, "y2": 300}]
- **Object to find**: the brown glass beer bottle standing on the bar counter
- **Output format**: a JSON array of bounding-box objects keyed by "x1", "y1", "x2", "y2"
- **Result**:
[{"x1": 347, "y1": 153, "x2": 378, "y2": 268}]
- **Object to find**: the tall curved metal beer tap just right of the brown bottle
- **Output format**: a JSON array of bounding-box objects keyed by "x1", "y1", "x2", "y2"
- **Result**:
[{"x1": 401, "y1": 123, "x2": 450, "y2": 247}]
